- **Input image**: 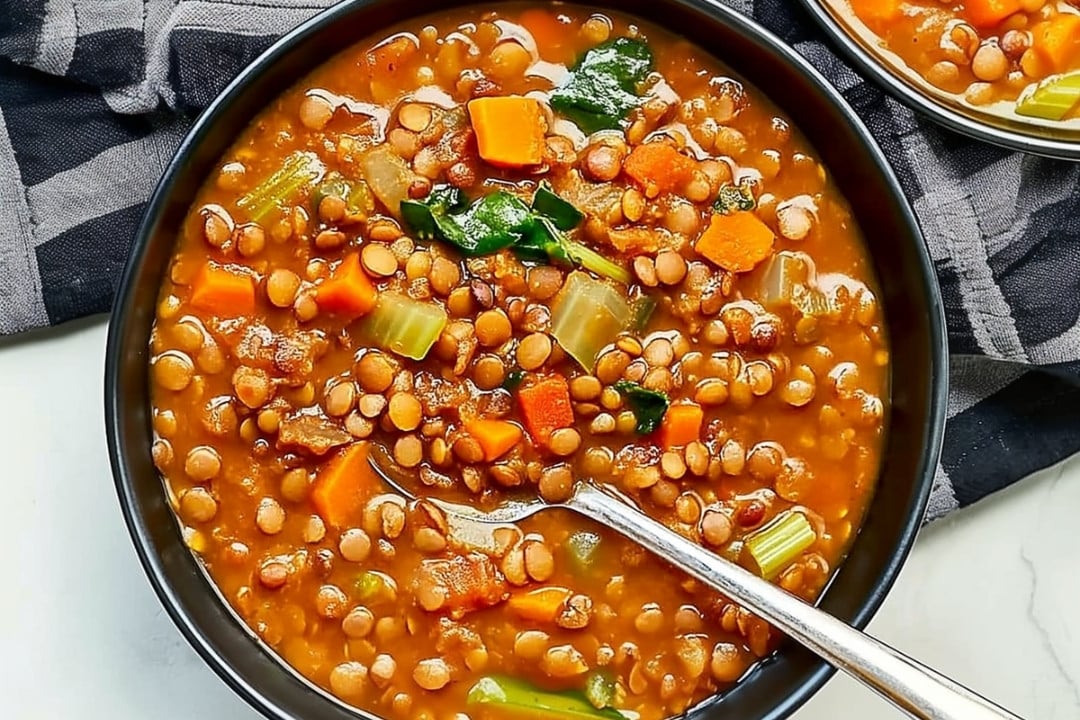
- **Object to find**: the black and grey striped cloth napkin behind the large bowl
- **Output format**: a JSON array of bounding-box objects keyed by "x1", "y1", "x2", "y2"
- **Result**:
[{"x1": 0, "y1": 0, "x2": 1080, "y2": 519}]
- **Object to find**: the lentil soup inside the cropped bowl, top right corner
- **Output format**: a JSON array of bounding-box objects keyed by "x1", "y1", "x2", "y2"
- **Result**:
[{"x1": 823, "y1": 0, "x2": 1080, "y2": 130}]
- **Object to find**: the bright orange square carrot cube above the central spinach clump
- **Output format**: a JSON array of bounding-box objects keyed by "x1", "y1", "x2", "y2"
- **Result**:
[{"x1": 469, "y1": 95, "x2": 548, "y2": 167}]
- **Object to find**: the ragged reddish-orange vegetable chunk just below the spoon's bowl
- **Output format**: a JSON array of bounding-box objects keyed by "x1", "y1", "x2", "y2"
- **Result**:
[{"x1": 416, "y1": 553, "x2": 507, "y2": 612}]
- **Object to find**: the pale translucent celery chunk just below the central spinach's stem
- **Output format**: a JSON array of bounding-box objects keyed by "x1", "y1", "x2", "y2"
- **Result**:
[{"x1": 551, "y1": 272, "x2": 632, "y2": 372}]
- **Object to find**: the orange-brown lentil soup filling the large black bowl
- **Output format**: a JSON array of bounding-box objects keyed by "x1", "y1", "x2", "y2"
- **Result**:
[{"x1": 151, "y1": 4, "x2": 890, "y2": 720}]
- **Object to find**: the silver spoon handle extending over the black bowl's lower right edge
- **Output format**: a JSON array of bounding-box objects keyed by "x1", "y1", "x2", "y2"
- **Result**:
[{"x1": 566, "y1": 483, "x2": 1021, "y2": 720}]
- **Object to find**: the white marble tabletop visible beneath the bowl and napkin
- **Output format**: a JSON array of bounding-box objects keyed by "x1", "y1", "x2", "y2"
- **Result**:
[{"x1": 0, "y1": 322, "x2": 1080, "y2": 720}]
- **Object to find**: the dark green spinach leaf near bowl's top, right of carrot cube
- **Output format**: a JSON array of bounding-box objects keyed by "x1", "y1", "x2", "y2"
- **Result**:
[{"x1": 551, "y1": 38, "x2": 652, "y2": 133}]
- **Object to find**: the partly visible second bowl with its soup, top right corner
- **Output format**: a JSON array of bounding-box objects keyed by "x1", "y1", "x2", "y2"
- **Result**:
[{"x1": 806, "y1": 0, "x2": 1080, "y2": 159}]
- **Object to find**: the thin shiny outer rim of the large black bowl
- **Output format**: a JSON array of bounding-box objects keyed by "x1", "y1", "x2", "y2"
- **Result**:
[{"x1": 104, "y1": 0, "x2": 948, "y2": 720}]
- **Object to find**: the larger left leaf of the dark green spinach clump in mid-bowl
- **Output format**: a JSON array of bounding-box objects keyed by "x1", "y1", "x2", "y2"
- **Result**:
[{"x1": 401, "y1": 186, "x2": 534, "y2": 257}]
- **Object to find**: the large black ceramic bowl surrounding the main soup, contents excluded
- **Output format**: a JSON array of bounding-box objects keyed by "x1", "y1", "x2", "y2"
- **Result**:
[{"x1": 105, "y1": 0, "x2": 946, "y2": 720}]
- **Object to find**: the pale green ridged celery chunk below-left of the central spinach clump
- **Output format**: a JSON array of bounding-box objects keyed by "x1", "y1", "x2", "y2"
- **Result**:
[{"x1": 363, "y1": 293, "x2": 447, "y2": 359}]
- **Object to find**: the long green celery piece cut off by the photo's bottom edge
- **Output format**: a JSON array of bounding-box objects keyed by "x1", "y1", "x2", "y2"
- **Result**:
[{"x1": 465, "y1": 676, "x2": 626, "y2": 720}]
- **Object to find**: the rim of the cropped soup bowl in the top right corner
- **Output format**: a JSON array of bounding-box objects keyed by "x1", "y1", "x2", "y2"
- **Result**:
[{"x1": 799, "y1": 0, "x2": 1080, "y2": 161}]
